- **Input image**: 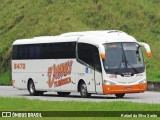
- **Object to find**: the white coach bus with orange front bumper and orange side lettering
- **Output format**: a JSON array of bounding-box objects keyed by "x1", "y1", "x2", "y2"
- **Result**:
[{"x1": 12, "y1": 30, "x2": 151, "y2": 98}]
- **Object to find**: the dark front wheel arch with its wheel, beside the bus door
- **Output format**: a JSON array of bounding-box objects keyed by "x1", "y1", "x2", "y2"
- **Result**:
[{"x1": 78, "y1": 79, "x2": 91, "y2": 98}]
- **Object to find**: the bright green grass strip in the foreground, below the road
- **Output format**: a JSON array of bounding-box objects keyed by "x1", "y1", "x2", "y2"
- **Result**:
[{"x1": 0, "y1": 97, "x2": 160, "y2": 120}]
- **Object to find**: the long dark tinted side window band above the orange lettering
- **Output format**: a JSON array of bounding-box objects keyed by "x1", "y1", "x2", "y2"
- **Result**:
[{"x1": 12, "y1": 42, "x2": 76, "y2": 59}]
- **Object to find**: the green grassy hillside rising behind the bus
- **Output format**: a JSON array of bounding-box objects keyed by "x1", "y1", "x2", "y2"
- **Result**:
[{"x1": 0, "y1": 0, "x2": 160, "y2": 84}]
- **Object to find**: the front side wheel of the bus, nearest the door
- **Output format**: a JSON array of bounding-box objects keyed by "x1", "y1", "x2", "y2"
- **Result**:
[{"x1": 80, "y1": 82, "x2": 91, "y2": 98}]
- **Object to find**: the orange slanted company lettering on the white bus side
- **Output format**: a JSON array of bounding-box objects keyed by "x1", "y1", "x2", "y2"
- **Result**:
[{"x1": 48, "y1": 60, "x2": 73, "y2": 88}]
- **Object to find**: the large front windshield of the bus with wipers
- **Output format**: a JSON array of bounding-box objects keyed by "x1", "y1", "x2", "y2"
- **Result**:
[{"x1": 103, "y1": 43, "x2": 145, "y2": 75}]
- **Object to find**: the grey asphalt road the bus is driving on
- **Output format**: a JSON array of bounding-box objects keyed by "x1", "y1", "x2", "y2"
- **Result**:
[{"x1": 0, "y1": 86, "x2": 160, "y2": 104}]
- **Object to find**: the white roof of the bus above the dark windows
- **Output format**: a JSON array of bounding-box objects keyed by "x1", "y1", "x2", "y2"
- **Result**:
[{"x1": 13, "y1": 30, "x2": 137, "y2": 45}]
